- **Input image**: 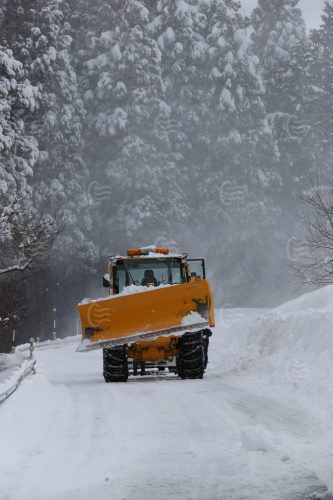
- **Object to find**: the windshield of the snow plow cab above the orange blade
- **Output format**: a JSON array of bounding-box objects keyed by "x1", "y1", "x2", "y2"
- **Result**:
[{"x1": 115, "y1": 258, "x2": 184, "y2": 293}]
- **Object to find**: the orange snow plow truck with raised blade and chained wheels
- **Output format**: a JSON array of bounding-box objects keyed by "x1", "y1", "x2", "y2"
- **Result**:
[{"x1": 77, "y1": 247, "x2": 215, "y2": 382}]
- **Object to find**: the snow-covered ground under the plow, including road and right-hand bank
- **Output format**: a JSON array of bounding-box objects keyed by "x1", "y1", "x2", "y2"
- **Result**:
[{"x1": 0, "y1": 289, "x2": 333, "y2": 500}]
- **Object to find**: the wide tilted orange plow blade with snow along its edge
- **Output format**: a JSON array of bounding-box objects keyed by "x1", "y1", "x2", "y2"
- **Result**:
[{"x1": 76, "y1": 279, "x2": 214, "y2": 351}]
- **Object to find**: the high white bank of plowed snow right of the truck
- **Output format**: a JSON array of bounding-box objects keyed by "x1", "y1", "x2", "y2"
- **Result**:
[{"x1": 213, "y1": 286, "x2": 333, "y2": 413}]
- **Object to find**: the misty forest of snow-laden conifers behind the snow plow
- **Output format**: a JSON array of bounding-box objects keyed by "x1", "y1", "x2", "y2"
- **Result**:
[{"x1": 0, "y1": 0, "x2": 333, "y2": 341}]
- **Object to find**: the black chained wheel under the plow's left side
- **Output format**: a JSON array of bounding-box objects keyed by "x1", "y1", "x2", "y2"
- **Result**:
[{"x1": 103, "y1": 346, "x2": 128, "y2": 382}]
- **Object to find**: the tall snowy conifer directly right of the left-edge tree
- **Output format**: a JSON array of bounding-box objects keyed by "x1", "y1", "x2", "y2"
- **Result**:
[{"x1": 5, "y1": 0, "x2": 95, "y2": 270}]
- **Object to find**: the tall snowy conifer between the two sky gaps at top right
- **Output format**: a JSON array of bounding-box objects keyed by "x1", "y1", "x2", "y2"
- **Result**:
[{"x1": 252, "y1": 0, "x2": 311, "y2": 236}]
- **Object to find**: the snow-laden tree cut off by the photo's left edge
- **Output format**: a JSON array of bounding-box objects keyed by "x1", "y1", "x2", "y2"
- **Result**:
[{"x1": 0, "y1": 47, "x2": 49, "y2": 274}]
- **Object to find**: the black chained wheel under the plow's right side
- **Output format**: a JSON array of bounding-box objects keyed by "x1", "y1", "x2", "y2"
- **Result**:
[{"x1": 177, "y1": 330, "x2": 206, "y2": 379}]
